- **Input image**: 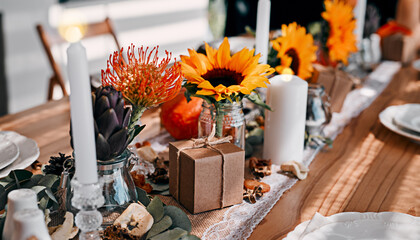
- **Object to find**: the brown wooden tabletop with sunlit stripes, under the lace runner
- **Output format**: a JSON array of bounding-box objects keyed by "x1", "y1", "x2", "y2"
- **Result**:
[{"x1": 0, "y1": 68, "x2": 420, "y2": 239}]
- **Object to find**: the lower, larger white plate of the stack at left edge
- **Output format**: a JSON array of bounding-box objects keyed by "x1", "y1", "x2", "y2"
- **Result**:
[{"x1": 0, "y1": 131, "x2": 39, "y2": 178}]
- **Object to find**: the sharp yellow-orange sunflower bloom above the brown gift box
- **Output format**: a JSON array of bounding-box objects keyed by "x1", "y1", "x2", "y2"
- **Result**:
[{"x1": 181, "y1": 38, "x2": 274, "y2": 101}]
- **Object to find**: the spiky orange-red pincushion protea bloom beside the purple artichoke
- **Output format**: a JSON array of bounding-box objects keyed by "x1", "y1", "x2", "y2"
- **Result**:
[{"x1": 102, "y1": 44, "x2": 183, "y2": 109}]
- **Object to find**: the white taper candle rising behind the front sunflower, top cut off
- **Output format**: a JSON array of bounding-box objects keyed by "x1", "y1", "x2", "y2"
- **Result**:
[{"x1": 255, "y1": 0, "x2": 271, "y2": 64}]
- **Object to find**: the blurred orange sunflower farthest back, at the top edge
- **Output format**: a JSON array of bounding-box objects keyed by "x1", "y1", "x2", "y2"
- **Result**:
[{"x1": 321, "y1": 0, "x2": 357, "y2": 64}]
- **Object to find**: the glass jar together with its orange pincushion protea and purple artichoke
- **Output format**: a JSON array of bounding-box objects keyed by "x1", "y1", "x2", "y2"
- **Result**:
[{"x1": 72, "y1": 44, "x2": 182, "y2": 226}]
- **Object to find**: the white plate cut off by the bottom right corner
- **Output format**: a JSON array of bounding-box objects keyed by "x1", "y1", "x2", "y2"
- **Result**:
[{"x1": 285, "y1": 212, "x2": 420, "y2": 240}]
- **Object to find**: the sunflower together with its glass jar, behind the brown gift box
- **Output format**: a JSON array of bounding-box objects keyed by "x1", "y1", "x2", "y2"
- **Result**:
[{"x1": 181, "y1": 38, "x2": 274, "y2": 148}]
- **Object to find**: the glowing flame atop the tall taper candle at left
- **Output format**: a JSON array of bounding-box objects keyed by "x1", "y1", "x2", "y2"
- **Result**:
[{"x1": 58, "y1": 10, "x2": 87, "y2": 42}]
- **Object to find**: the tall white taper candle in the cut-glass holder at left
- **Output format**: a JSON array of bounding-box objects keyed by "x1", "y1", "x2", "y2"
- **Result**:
[{"x1": 67, "y1": 41, "x2": 98, "y2": 184}]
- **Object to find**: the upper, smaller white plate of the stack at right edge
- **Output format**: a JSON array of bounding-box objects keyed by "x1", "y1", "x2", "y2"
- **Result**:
[{"x1": 394, "y1": 103, "x2": 420, "y2": 134}]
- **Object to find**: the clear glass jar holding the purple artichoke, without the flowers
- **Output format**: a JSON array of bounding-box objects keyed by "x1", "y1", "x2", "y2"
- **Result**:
[{"x1": 98, "y1": 149, "x2": 137, "y2": 226}]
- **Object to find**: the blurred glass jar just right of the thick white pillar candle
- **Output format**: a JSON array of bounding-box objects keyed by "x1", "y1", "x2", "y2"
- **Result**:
[{"x1": 305, "y1": 84, "x2": 331, "y2": 136}]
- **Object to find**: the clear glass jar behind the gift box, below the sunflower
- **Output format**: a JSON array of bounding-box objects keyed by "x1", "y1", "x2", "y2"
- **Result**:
[{"x1": 198, "y1": 101, "x2": 245, "y2": 149}]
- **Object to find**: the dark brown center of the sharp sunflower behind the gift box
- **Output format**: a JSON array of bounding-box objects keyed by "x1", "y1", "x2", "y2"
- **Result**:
[{"x1": 203, "y1": 68, "x2": 244, "y2": 87}]
